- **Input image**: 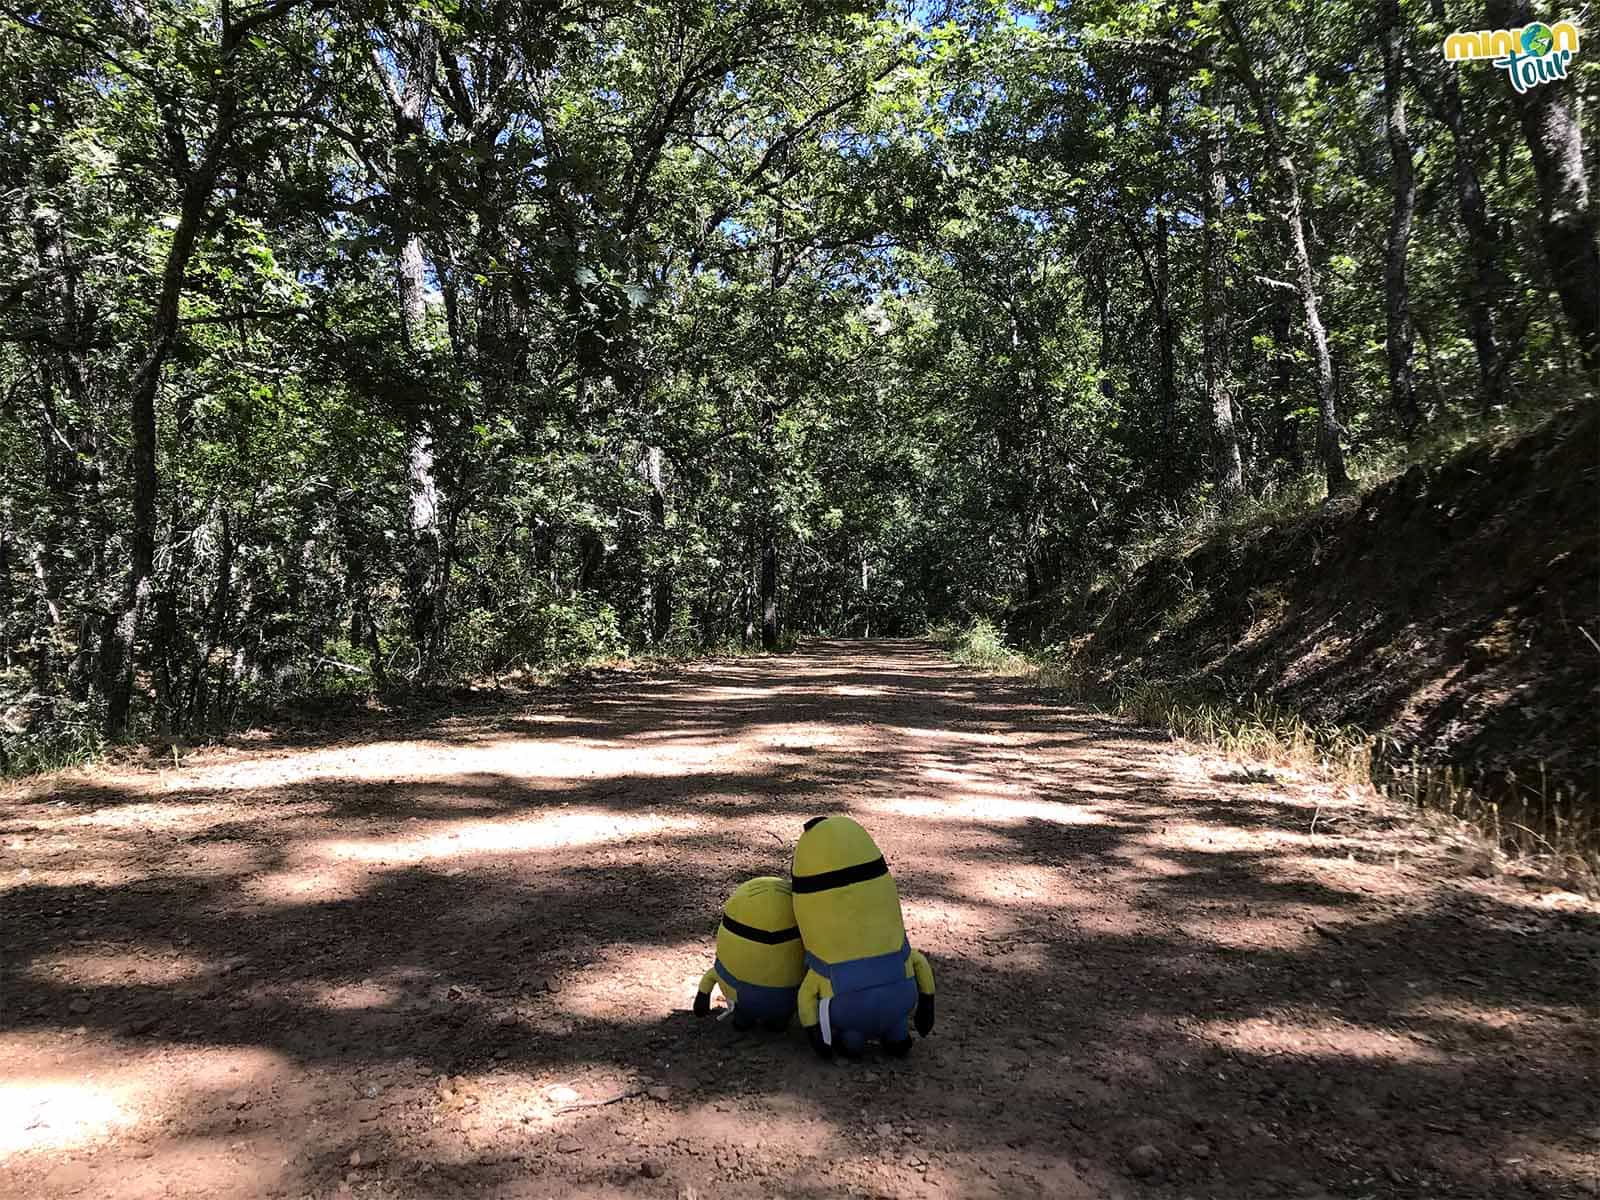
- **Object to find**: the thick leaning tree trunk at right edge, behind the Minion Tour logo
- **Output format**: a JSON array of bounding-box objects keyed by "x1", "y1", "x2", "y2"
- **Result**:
[{"x1": 1488, "y1": 0, "x2": 1600, "y2": 376}]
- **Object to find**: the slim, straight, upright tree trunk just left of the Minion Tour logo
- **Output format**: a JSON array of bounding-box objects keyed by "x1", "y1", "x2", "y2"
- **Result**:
[{"x1": 1382, "y1": 0, "x2": 1421, "y2": 432}]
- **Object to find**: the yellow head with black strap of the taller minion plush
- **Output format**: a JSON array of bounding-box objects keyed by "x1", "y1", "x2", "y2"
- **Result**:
[{"x1": 792, "y1": 816, "x2": 906, "y2": 963}]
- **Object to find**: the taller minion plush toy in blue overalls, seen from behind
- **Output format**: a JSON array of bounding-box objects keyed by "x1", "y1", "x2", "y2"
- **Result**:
[{"x1": 790, "y1": 816, "x2": 933, "y2": 1058}]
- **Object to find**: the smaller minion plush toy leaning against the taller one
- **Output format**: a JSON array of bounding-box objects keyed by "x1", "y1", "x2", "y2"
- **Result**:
[{"x1": 694, "y1": 875, "x2": 805, "y2": 1034}]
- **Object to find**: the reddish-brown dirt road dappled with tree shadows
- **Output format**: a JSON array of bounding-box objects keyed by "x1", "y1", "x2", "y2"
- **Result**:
[{"x1": 0, "y1": 642, "x2": 1600, "y2": 1200}]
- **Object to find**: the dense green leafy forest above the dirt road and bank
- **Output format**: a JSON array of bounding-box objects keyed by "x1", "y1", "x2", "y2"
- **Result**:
[{"x1": 0, "y1": 0, "x2": 1600, "y2": 758}]
